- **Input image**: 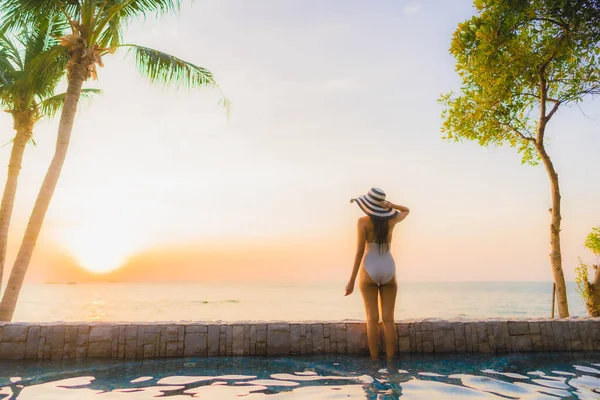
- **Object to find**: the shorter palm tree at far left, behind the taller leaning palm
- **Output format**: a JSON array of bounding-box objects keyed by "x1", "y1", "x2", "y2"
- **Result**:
[{"x1": 0, "y1": 18, "x2": 98, "y2": 294}]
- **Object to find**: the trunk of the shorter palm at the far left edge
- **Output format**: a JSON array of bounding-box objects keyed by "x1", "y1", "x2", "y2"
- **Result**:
[{"x1": 0, "y1": 111, "x2": 35, "y2": 292}]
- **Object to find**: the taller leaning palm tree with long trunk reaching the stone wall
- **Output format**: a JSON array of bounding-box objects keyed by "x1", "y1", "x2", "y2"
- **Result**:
[{"x1": 0, "y1": 0, "x2": 221, "y2": 321}]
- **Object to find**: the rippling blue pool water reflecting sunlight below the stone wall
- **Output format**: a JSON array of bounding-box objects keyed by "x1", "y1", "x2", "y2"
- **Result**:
[{"x1": 0, "y1": 353, "x2": 600, "y2": 400}]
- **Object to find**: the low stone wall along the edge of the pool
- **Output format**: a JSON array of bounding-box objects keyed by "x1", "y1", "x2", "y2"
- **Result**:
[{"x1": 0, "y1": 318, "x2": 600, "y2": 360}]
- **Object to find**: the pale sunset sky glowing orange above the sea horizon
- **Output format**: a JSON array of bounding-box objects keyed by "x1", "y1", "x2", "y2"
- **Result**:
[{"x1": 0, "y1": 0, "x2": 600, "y2": 282}]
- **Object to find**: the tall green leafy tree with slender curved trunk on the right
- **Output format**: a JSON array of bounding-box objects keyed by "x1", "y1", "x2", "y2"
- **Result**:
[{"x1": 440, "y1": 0, "x2": 600, "y2": 317}]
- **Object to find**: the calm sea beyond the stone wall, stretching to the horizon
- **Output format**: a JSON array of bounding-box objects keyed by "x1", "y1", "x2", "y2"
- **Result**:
[{"x1": 14, "y1": 282, "x2": 586, "y2": 321}]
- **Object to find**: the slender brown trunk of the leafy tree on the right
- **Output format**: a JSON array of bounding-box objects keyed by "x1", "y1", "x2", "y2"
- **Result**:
[{"x1": 536, "y1": 143, "x2": 569, "y2": 318}]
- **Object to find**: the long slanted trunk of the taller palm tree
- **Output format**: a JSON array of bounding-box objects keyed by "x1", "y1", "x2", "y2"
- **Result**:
[{"x1": 0, "y1": 59, "x2": 91, "y2": 321}]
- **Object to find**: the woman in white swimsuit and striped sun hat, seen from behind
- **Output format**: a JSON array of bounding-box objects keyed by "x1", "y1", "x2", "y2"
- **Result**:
[{"x1": 346, "y1": 188, "x2": 410, "y2": 358}]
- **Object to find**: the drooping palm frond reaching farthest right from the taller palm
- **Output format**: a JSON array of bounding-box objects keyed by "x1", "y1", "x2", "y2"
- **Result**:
[{"x1": 120, "y1": 44, "x2": 216, "y2": 89}]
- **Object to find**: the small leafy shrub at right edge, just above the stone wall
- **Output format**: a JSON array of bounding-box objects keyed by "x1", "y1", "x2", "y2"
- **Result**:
[{"x1": 575, "y1": 226, "x2": 600, "y2": 317}]
